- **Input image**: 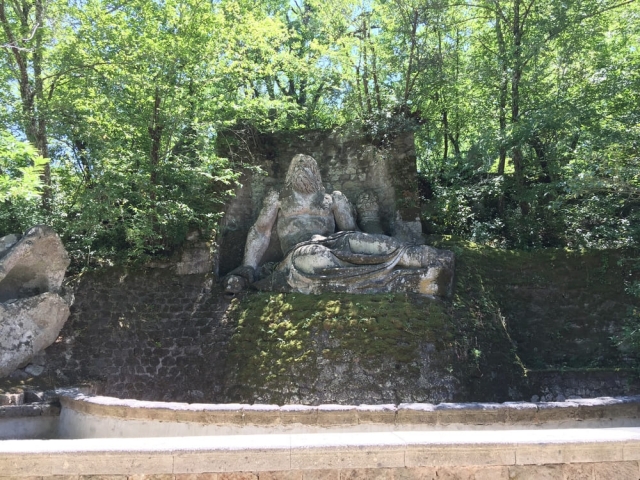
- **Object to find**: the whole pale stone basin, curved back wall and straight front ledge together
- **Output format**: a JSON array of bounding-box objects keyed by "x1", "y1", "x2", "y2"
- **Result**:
[{"x1": 0, "y1": 390, "x2": 640, "y2": 480}]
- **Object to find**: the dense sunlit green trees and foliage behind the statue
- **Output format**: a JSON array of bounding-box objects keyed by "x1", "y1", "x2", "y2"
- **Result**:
[{"x1": 0, "y1": 0, "x2": 640, "y2": 265}]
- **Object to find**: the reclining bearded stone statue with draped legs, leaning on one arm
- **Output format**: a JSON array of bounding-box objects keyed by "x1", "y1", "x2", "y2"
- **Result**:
[{"x1": 223, "y1": 155, "x2": 454, "y2": 296}]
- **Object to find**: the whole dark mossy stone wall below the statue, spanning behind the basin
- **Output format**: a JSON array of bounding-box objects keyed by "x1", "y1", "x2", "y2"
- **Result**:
[{"x1": 8, "y1": 242, "x2": 639, "y2": 404}]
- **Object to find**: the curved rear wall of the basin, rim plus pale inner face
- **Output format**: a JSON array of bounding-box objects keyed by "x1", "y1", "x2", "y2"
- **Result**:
[{"x1": 53, "y1": 391, "x2": 640, "y2": 438}]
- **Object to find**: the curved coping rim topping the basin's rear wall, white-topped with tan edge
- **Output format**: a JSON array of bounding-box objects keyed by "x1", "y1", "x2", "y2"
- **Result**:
[{"x1": 59, "y1": 390, "x2": 640, "y2": 434}]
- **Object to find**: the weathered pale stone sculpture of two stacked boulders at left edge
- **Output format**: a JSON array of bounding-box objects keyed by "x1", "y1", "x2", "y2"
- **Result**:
[{"x1": 0, "y1": 226, "x2": 71, "y2": 378}]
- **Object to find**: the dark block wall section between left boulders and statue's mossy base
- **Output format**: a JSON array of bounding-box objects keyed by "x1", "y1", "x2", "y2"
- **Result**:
[{"x1": 42, "y1": 267, "x2": 234, "y2": 402}]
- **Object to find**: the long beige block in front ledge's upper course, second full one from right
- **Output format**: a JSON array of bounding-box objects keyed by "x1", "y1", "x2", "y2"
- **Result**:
[{"x1": 405, "y1": 445, "x2": 515, "y2": 467}]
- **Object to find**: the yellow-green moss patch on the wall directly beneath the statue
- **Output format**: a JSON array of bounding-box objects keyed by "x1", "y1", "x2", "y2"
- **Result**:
[{"x1": 228, "y1": 293, "x2": 451, "y2": 400}]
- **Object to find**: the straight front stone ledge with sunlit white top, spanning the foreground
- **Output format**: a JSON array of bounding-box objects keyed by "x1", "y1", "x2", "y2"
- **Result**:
[{"x1": 0, "y1": 428, "x2": 640, "y2": 480}]
